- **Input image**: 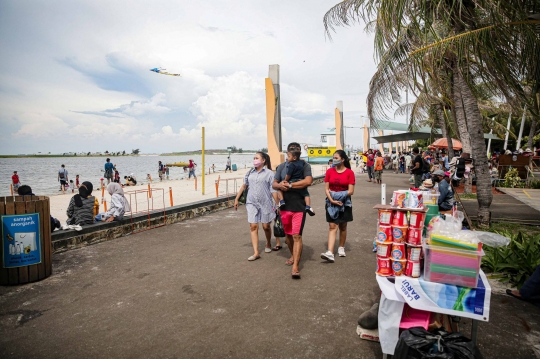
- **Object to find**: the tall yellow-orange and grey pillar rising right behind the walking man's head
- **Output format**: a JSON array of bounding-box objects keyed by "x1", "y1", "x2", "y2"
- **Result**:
[{"x1": 265, "y1": 65, "x2": 285, "y2": 168}]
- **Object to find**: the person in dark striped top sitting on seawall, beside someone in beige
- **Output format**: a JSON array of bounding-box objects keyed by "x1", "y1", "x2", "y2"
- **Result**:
[{"x1": 66, "y1": 181, "x2": 99, "y2": 226}]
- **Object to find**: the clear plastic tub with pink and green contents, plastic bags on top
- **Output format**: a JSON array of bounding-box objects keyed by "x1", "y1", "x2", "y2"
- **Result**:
[{"x1": 423, "y1": 216, "x2": 484, "y2": 288}]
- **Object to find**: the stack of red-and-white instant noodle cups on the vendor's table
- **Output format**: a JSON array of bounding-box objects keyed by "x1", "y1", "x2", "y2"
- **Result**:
[{"x1": 376, "y1": 209, "x2": 425, "y2": 278}]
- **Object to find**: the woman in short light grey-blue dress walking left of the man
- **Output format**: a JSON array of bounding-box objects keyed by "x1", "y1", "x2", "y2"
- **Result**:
[{"x1": 234, "y1": 152, "x2": 277, "y2": 261}]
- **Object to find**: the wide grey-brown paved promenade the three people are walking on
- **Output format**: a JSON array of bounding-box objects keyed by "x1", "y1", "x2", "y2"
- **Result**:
[{"x1": 0, "y1": 171, "x2": 540, "y2": 359}]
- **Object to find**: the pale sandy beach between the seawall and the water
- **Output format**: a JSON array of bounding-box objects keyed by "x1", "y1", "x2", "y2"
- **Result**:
[{"x1": 49, "y1": 165, "x2": 326, "y2": 224}]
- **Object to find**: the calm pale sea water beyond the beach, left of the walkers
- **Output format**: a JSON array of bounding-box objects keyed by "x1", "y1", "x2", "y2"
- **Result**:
[{"x1": 0, "y1": 154, "x2": 253, "y2": 196}]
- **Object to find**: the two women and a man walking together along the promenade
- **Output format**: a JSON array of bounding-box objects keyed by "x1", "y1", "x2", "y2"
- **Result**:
[{"x1": 234, "y1": 142, "x2": 355, "y2": 279}]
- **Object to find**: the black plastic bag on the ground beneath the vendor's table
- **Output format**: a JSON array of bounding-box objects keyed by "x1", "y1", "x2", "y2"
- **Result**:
[{"x1": 394, "y1": 327, "x2": 483, "y2": 359}]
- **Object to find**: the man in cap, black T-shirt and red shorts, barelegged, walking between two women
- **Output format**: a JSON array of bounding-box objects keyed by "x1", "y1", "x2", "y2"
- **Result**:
[{"x1": 272, "y1": 142, "x2": 313, "y2": 279}]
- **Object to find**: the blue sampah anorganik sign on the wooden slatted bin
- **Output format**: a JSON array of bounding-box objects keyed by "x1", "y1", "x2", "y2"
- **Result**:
[{"x1": 2, "y1": 213, "x2": 41, "y2": 268}]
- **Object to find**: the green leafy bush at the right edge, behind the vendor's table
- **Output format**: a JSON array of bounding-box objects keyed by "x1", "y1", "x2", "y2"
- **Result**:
[{"x1": 482, "y1": 232, "x2": 540, "y2": 289}]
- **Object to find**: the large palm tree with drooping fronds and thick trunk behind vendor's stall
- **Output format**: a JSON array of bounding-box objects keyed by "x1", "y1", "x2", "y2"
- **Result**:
[{"x1": 324, "y1": 0, "x2": 540, "y2": 225}]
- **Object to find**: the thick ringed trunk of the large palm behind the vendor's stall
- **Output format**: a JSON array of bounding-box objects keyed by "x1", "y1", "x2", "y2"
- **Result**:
[{"x1": 454, "y1": 70, "x2": 493, "y2": 227}]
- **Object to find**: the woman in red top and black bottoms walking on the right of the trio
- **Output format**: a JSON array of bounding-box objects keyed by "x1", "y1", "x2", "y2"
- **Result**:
[{"x1": 321, "y1": 150, "x2": 356, "y2": 263}]
